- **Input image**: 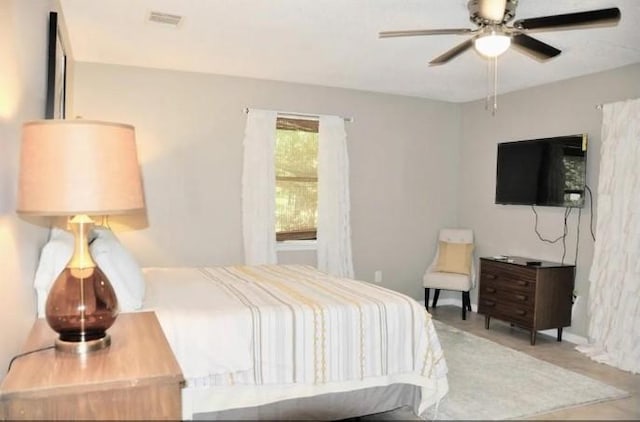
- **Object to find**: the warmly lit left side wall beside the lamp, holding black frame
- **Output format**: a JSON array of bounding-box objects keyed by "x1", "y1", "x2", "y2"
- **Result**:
[{"x1": 0, "y1": 0, "x2": 54, "y2": 380}]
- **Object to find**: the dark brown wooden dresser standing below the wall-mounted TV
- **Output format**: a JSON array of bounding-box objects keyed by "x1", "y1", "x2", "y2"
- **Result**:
[{"x1": 478, "y1": 256, "x2": 575, "y2": 345}]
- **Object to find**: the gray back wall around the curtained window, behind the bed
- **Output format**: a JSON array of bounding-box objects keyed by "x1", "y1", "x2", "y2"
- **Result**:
[{"x1": 73, "y1": 63, "x2": 461, "y2": 299}]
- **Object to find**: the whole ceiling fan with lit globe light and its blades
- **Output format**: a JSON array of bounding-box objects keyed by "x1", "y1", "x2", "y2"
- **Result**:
[{"x1": 379, "y1": 0, "x2": 620, "y2": 66}]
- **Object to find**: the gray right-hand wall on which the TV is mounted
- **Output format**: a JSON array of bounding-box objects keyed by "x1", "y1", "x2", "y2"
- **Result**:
[{"x1": 458, "y1": 64, "x2": 640, "y2": 337}]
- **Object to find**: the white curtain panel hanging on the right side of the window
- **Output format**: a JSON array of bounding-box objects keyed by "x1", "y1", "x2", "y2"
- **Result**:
[{"x1": 317, "y1": 116, "x2": 353, "y2": 278}]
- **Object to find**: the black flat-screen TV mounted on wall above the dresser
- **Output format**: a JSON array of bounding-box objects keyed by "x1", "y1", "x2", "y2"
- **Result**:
[{"x1": 496, "y1": 134, "x2": 587, "y2": 207}]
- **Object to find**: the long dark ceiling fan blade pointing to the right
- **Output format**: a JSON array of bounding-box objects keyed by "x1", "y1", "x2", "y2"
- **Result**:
[{"x1": 513, "y1": 7, "x2": 620, "y2": 31}]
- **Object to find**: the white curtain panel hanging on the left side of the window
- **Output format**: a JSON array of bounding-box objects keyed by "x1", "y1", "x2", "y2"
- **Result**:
[{"x1": 242, "y1": 110, "x2": 277, "y2": 265}]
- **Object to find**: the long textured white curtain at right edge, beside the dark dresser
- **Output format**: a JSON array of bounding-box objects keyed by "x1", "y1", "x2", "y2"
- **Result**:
[{"x1": 578, "y1": 99, "x2": 640, "y2": 373}]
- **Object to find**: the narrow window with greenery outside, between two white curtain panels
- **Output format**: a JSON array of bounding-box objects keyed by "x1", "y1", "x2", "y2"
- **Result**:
[{"x1": 275, "y1": 117, "x2": 318, "y2": 241}]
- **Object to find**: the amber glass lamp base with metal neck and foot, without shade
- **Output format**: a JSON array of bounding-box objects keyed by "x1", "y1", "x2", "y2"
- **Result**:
[{"x1": 45, "y1": 218, "x2": 118, "y2": 354}]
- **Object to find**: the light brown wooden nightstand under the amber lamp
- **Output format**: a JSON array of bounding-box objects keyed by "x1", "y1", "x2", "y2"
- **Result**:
[{"x1": 0, "y1": 312, "x2": 184, "y2": 420}]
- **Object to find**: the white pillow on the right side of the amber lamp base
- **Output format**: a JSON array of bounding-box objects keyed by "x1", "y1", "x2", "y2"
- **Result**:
[{"x1": 89, "y1": 227, "x2": 145, "y2": 312}]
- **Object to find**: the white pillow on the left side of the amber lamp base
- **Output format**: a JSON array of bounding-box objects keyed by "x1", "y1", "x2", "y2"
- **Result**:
[{"x1": 33, "y1": 227, "x2": 74, "y2": 318}]
